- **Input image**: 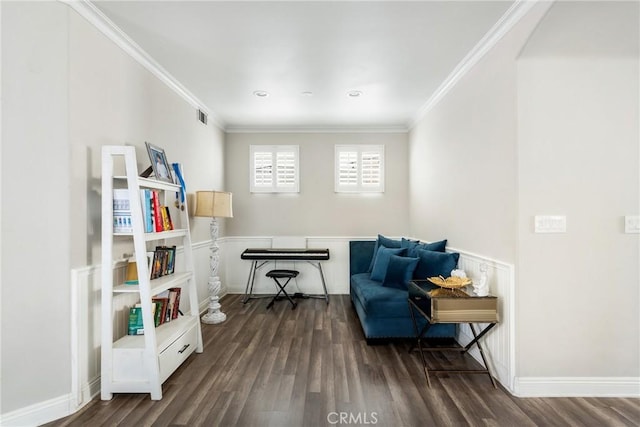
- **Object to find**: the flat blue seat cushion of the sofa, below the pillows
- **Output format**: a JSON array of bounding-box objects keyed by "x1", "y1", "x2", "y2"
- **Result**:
[{"x1": 351, "y1": 273, "x2": 411, "y2": 318}]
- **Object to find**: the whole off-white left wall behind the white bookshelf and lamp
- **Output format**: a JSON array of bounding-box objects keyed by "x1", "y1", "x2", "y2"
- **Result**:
[{"x1": 0, "y1": 2, "x2": 224, "y2": 424}]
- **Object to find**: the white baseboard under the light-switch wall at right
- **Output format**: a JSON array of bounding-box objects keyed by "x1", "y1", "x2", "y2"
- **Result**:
[{"x1": 513, "y1": 377, "x2": 640, "y2": 397}]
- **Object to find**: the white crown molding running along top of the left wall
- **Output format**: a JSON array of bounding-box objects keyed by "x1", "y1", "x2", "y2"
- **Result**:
[{"x1": 58, "y1": 0, "x2": 225, "y2": 130}]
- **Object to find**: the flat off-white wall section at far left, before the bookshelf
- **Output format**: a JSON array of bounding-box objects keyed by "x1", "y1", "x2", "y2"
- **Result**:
[{"x1": 0, "y1": 2, "x2": 71, "y2": 418}]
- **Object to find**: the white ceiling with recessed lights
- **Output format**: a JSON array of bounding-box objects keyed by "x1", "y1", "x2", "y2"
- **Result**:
[{"x1": 93, "y1": 0, "x2": 513, "y2": 130}]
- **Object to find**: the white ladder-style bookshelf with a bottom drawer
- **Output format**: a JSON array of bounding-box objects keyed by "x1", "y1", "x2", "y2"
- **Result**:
[{"x1": 101, "y1": 146, "x2": 203, "y2": 400}]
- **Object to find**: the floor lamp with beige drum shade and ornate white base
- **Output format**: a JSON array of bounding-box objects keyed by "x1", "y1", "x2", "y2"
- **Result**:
[{"x1": 195, "y1": 191, "x2": 233, "y2": 324}]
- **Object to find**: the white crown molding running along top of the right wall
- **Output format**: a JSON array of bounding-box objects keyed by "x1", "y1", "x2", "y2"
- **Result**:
[{"x1": 407, "y1": 0, "x2": 536, "y2": 130}]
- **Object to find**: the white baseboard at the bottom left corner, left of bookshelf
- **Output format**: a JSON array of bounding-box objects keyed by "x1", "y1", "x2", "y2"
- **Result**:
[{"x1": 0, "y1": 394, "x2": 75, "y2": 427}]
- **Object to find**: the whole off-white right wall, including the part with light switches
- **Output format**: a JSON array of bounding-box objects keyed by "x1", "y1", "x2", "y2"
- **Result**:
[{"x1": 409, "y1": 2, "x2": 640, "y2": 396}]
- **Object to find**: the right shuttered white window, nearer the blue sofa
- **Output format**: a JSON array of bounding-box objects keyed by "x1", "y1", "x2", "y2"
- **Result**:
[{"x1": 335, "y1": 145, "x2": 384, "y2": 193}]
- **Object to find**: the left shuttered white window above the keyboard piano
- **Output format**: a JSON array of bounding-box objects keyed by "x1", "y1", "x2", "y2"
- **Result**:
[{"x1": 249, "y1": 145, "x2": 300, "y2": 193}]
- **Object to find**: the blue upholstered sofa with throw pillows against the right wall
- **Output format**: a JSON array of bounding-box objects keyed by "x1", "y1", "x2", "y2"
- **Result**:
[{"x1": 349, "y1": 235, "x2": 459, "y2": 344}]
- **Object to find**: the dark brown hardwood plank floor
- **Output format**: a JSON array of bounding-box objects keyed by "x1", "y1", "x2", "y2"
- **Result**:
[{"x1": 48, "y1": 295, "x2": 640, "y2": 427}]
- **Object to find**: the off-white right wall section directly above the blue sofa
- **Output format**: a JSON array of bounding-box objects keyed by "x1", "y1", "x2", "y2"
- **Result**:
[{"x1": 409, "y1": 4, "x2": 548, "y2": 263}]
